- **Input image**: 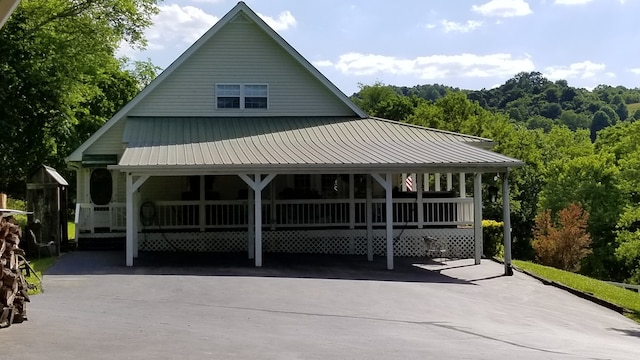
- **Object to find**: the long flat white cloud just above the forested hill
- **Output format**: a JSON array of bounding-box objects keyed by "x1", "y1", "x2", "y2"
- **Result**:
[{"x1": 315, "y1": 53, "x2": 535, "y2": 80}]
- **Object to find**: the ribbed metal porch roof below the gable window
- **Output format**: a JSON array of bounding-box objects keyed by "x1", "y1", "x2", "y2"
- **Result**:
[{"x1": 113, "y1": 117, "x2": 522, "y2": 172}]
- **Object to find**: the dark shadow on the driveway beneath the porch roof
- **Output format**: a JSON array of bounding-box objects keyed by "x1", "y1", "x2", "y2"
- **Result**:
[{"x1": 46, "y1": 251, "x2": 484, "y2": 285}]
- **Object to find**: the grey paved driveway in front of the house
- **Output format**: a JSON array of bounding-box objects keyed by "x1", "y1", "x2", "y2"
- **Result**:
[{"x1": 0, "y1": 252, "x2": 640, "y2": 360}]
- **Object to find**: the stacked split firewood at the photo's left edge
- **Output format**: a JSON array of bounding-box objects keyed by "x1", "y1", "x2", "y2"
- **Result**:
[{"x1": 0, "y1": 217, "x2": 29, "y2": 328}]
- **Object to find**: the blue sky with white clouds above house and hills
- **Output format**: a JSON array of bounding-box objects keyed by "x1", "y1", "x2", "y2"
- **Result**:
[{"x1": 120, "y1": 0, "x2": 640, "y2": 95}]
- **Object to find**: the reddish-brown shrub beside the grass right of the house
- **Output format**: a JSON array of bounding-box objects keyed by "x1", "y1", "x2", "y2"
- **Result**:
[{"x1": 532, "y1": 204, "x2": 591, "y2": 272}]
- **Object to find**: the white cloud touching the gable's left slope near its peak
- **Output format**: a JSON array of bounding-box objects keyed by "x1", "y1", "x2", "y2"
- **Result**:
[{"x1": 146, "y1": 4, "x2": 219, "y2": 49}]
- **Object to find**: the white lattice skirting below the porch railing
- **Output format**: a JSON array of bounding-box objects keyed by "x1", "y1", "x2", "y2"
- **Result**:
[{"x1": 139, "y1": 229, "x2": 474, "y2": 259}]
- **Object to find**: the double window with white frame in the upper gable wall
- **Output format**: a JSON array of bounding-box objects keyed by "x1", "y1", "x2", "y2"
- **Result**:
[{"x1": 216, "y1": 84, "x2": 269, "y2": 109}]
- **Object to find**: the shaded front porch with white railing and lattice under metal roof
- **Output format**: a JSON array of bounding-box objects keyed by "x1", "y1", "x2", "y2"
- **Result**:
[{"x1": 76, "y1": 173, "x2": 510, "y2": 269}]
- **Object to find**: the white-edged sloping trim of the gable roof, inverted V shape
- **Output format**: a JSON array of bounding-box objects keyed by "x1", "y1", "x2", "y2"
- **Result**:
[{"x1": 65, "y1": 1, "x2": 367, "y2": 161}]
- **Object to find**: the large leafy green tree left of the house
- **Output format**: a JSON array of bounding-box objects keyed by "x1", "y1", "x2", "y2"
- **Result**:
[{"x1": 0, "y1": 0, "x2": 157, "y2": 197}]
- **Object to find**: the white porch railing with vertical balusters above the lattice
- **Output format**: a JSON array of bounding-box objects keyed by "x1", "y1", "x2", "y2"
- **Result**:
[{"x1": 76, "y1": 198, "x2": 473, "y2": 232}]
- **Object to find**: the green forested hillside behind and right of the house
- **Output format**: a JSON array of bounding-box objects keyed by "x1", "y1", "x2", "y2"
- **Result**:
[{"x1": 352, "y1": 73, "x2": 640, "y2": 283}]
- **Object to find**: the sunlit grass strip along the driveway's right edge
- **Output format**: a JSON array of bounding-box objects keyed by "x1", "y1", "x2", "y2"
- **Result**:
[{"x1": 512, "y1": 260, "x2": 640, "y2": 322}]
